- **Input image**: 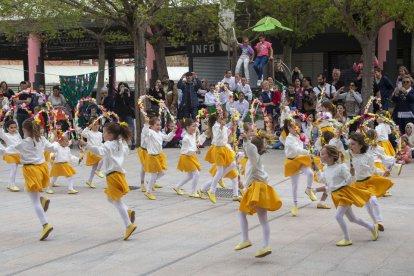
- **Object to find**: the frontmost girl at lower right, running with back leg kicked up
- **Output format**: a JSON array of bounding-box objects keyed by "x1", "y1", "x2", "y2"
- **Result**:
[{"x1": 315, "y1": 145, "x2": 378, "y2": 246}]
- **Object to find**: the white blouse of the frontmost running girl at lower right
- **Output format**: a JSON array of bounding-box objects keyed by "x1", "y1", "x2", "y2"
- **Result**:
[{"x1": 317, "y1": 164, "x2": 352, "y2": 192}]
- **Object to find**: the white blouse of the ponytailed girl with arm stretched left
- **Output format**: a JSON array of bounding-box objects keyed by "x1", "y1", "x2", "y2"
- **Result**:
[{"x1": 86, "y1": 140, "x2": 129, "y2": 175}]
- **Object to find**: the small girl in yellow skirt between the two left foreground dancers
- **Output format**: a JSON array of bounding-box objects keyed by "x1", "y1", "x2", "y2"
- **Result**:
[{"x1": 46, "y1": 134, "x2": 79, "y2": 195}]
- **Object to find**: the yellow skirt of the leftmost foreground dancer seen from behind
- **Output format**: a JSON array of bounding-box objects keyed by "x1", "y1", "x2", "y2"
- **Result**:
[{"x1": 23, "y1": 162, "x2": 50, "y2": 192}]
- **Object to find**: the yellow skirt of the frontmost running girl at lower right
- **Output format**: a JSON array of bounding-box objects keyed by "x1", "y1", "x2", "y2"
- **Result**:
[{"x1": 331, "y1": 186, "x2": 371, "y2": 208}]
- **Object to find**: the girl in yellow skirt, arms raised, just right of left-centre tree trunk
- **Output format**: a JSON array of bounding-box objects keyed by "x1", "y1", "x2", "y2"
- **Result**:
[{"x1": 144, "y1": 117, "x2": 177, "y2": 200}]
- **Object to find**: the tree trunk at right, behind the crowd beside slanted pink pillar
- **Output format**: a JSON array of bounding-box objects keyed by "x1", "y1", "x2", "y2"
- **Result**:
[{"x1": 360, "y1": 38, "x2": 376, "y2": 109}]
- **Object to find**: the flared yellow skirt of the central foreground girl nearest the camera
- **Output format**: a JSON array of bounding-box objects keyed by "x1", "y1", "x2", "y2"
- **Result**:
[{"x1": 239, "y1": 181, "x2": 282, "y2": 215}]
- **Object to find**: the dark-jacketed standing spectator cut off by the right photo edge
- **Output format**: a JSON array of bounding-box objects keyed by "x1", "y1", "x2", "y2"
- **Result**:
[{"x1": 391, "y1": 76, "x2": 414, "y2": 132}]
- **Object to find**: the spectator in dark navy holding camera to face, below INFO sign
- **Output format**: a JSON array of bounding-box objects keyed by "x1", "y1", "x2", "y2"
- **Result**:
[{"x1": 177, "y1": 72, "x2": 201, "y2": 120}]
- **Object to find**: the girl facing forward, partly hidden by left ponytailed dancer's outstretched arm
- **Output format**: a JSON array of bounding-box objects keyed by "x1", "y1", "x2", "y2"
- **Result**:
[{"x1": 82, "y1": 118, "x2": 104, "y2": 189}]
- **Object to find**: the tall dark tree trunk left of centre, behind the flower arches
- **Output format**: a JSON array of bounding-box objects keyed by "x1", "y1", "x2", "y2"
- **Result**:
[{"x1": 132, "y1": 26, "x2": 146, "y2": 146}]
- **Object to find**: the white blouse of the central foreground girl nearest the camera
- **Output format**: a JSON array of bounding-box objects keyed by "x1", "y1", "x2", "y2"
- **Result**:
[{"x1": 244, "y1": 140, "x2": 268, "y2": 186}]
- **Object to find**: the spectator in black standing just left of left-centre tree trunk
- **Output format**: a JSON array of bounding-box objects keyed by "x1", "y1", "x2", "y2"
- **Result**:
[{"x1": 114, "y1": 82, "x2": 135, "y2": 150}]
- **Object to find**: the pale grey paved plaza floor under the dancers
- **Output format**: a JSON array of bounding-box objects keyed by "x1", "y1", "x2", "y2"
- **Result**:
[{"x1": 0, "y1": 149, "x2": 414, "y2": 276}]
